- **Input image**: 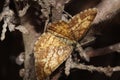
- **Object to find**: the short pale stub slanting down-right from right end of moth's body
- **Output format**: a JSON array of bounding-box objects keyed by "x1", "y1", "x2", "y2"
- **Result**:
[{"x1": 76, "y1": 43, "x2": 90, "y2": 62}]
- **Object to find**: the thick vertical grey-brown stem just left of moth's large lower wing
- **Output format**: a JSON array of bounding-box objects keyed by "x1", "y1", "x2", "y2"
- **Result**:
[{"x1": 23, "y1": 23, "x2": 38, "y2": 80}]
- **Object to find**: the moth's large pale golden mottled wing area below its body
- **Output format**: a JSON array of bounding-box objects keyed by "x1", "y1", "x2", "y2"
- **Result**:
[{"x1": 34, "y1": 32, "x2": 73, "y2": 80}]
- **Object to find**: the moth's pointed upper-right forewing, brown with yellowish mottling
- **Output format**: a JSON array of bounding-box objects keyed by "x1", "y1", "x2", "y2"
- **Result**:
[{"x1": 68, "y1": 8, "x2": 97, "y2": 41}]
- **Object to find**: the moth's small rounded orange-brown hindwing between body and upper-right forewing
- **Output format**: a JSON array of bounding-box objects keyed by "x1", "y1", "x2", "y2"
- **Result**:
[{"x1": 47, "y1": 21, "x2": 74, "y2": 40}]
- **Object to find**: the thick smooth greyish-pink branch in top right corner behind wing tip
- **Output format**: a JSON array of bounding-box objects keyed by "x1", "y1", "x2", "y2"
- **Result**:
[{"x1": 92, "y1": 0, "x2": 120, "y2": 24}]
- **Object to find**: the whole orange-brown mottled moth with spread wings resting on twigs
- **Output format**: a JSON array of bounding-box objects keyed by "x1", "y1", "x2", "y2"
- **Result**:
[{"x1": 34, "y1": 8, "x2": 97, "y2": 80}]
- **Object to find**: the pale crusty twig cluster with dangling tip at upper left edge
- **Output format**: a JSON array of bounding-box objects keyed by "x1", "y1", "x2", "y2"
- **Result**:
[{"x1": 0, "y1": 0, "x2": 27, "y2": 40}]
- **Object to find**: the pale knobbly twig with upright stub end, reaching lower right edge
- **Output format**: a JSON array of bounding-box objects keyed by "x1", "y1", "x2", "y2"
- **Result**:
[{"x1": 65, "y1": 57, "x2": 120, "y2": 76}]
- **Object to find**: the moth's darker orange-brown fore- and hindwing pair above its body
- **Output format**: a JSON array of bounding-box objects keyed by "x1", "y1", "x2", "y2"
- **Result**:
[{"x1": 47, "y1": 8, "x2": 97, "y2": 41}]
